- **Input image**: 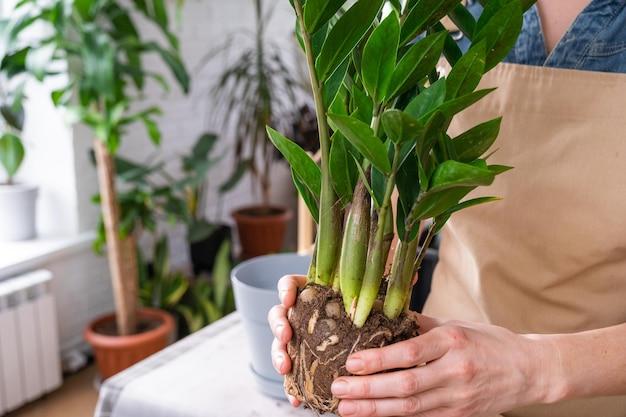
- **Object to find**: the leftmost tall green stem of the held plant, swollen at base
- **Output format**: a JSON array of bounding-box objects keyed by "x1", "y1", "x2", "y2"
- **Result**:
[{"x1": 293, "y1": 0, "x2": 343, "y2": 286}]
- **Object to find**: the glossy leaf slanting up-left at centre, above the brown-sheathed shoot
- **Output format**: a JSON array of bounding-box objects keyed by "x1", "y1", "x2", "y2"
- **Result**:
[{"x1": 328, "y1": 114, "x2": 391, "y2": 175}]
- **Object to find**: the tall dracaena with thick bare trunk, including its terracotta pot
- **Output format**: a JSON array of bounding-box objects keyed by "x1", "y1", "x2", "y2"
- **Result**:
[{"x1": 15, "y1": 0, "x2": 189, "y2": 378}]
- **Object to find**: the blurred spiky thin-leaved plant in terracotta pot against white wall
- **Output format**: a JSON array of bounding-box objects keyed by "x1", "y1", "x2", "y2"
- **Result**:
[{"x1": 208, "y1": 0, "x2": 299, "y2": 258}]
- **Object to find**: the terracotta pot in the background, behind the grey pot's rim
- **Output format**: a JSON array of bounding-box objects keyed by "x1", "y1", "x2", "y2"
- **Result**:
[{"x1": 232, "y1": 206, "x2": 291, "y2": 259}]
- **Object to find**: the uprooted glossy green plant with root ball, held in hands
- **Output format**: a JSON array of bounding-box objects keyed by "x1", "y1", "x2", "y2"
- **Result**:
[{"x1": 268, "y1": 0, "x2": 531, "y2": 413}]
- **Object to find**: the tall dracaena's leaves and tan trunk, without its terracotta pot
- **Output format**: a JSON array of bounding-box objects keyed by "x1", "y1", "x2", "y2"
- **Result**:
[{"x1": 12, "y1": 0, "x2": 189, "y2": 334}]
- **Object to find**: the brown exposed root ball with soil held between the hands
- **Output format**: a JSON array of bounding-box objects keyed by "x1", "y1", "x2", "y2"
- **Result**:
[{"x1": 285, "y1": 286, "x2": 417, "y2": 414}]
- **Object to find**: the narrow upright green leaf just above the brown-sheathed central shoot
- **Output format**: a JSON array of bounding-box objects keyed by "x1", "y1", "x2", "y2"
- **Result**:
[{"x1": 328, "y1": 132, "x2": 358, "y2": 205}]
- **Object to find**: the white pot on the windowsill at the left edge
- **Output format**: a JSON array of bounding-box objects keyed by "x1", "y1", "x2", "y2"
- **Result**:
[{"x1": 0, "y1": 184, "x2": 38, "y2": 242}]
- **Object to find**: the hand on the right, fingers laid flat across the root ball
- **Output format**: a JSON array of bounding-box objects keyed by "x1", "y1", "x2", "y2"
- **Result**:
[{"x1": 332, "y1": 316, "x2": 563, "y2": 417}]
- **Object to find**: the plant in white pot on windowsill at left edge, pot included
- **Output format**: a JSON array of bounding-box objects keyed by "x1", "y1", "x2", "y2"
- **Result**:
[{"x1": 0, "y1": 16, "x2": 37, "y2": 241}]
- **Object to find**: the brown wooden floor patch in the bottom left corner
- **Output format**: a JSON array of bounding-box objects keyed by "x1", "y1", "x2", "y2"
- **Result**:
[{"x1": 5, "y1": 365, "x2": 98, "y2": 417}]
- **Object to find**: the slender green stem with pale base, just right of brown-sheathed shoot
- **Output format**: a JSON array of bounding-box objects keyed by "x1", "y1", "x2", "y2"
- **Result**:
[{"x1": 353, "y1": 145, "x2": 400, "y2": 327}]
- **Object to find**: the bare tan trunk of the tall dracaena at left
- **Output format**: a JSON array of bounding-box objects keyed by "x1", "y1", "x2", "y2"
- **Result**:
[{"x1": 94, "y1": 139, "x2": 138, "y2": 336}]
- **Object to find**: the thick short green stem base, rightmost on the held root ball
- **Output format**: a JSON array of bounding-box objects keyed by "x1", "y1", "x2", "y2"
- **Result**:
[{"x1": 383, "y1": 234, "x2": 419, "y2": 320}]
